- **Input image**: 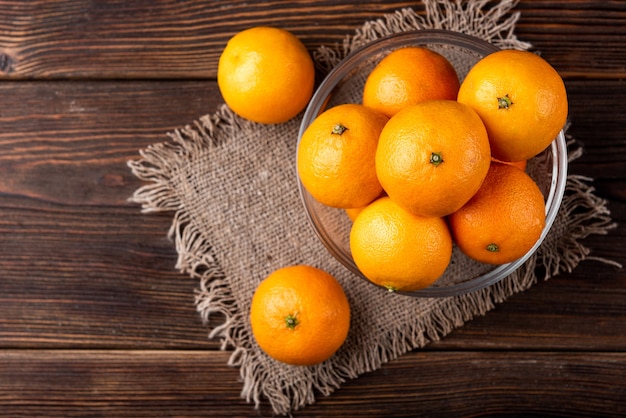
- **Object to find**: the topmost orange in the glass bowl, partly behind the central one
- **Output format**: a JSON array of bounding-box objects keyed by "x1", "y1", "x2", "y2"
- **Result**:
[{"x1": 363, "y1": 47, "x2": 459, "y2": 117}]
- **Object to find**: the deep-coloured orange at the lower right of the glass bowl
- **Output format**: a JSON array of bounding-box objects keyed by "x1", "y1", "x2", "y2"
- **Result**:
[{"x1": 448, "y1": 162, "x2": 546, "y2": 264}]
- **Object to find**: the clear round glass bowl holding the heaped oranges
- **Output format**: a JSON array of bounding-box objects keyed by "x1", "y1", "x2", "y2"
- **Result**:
[{"x1": 298, "y1": 30, "x2": 567, "y2": 297}]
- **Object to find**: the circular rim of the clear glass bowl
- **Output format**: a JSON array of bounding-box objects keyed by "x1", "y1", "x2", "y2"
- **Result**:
[{"x1": 296, "y1": 29, "x2": 568, "y2": 298}]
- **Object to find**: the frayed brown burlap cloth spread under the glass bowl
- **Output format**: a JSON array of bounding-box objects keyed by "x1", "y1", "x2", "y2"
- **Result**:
[{"x1": 129, "y1": 0, "x2": 615, "y2": 414}]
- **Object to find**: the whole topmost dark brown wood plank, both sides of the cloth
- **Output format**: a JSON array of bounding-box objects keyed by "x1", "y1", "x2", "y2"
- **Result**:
[{"x1": 0, "y1": 0, "x2": 626, "y2": 79}]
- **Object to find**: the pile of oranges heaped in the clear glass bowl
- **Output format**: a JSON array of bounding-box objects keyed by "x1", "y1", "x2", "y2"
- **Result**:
[{"x1": 297, "y1": 46, "x2": 567, "y2": 291}]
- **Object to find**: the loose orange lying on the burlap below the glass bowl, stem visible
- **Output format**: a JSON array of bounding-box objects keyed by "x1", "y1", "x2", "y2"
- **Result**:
[{"x1": 250, "y1": 265, "x2": 350, "y2": 366}]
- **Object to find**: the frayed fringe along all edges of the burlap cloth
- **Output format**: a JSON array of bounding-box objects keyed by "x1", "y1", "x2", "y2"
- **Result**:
[{"x1": 128, "y1": 0, "x2": 621, "y2": 414}]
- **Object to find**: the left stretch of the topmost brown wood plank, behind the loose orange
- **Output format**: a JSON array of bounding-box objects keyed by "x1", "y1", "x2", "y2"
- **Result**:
[{"x1": 0, "y1": 0, "x2": 420, "y2": 78}]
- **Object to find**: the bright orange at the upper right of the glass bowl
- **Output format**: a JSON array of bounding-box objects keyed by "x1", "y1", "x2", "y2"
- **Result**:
[{"x1": 458, "y1": 50, "x2": 567, "y2": 161}]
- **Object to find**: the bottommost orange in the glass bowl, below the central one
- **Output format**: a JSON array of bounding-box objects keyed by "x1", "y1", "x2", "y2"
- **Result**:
[{"x1": 350, "y1": 197, "x2": 452, "y2": 291}]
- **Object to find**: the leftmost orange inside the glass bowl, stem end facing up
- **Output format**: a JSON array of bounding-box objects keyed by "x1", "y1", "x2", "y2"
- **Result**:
[{"x1": 297, "y1": 104, "x2": 387, "y2": 208}]
